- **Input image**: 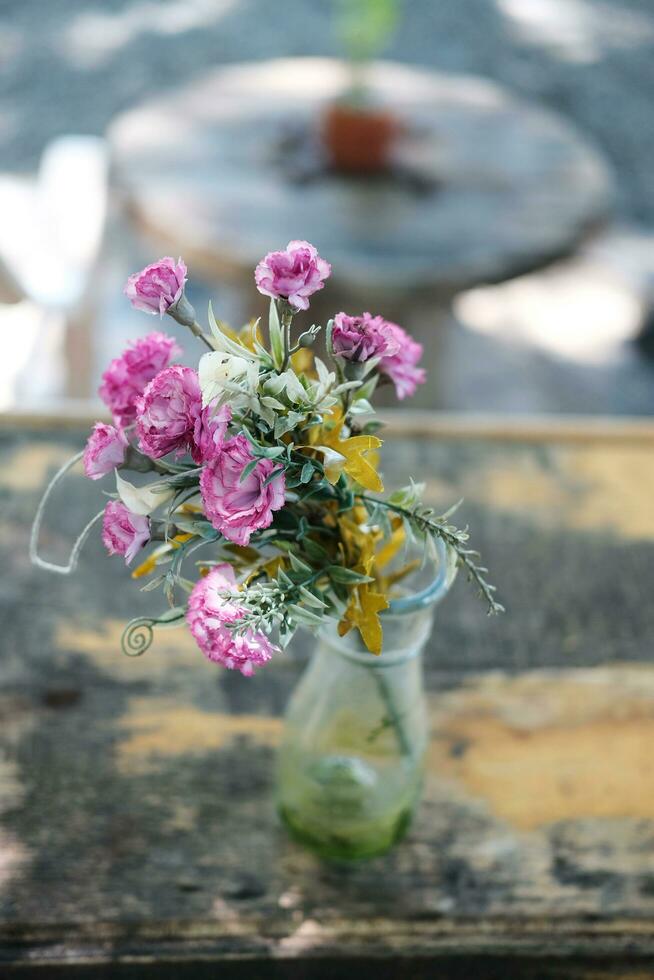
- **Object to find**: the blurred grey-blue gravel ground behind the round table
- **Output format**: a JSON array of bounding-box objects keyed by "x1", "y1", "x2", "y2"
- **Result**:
[{"x1": 0, "y1": 0, "x2": 654, "y2": 223}]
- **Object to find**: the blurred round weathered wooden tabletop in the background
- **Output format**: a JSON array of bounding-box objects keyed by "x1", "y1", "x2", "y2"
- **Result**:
[{"x1": 110, "y1": 58, "x2": 610, "y2": 302}]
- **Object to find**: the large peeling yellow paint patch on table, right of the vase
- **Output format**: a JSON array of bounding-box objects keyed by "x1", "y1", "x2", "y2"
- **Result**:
[{"x1": 430, "y1": 667, "x2": 654, "y2": 828}]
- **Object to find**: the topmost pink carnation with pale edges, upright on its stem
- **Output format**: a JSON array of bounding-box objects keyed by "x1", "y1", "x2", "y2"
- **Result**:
[{"x1": 254, "y1": 241, "x2": 332, "y2": 310}]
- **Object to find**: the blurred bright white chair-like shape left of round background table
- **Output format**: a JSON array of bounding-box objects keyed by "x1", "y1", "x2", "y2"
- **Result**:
[{"x1": 0, "y1": 135, "x2": 109, "y2": 404}]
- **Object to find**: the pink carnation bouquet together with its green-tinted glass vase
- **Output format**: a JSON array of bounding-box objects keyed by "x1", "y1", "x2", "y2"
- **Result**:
[{"x1": 31, "y1": 241, "x2": 502, "y2": 859}]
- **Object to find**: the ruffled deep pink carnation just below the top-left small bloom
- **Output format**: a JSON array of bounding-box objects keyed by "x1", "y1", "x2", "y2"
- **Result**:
[{"x1": 99, "y1": 332, "x2": 181, "y2": 428}]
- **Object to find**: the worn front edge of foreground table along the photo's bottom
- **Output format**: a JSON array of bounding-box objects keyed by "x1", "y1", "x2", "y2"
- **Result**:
[{"x1": 0, "y1": 913, "x2": 654, "y2": 966}]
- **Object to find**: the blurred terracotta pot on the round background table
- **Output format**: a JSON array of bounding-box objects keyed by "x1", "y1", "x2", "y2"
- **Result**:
[{"x1": 322, "y1": 102, "x2": 399, "y2": 174}]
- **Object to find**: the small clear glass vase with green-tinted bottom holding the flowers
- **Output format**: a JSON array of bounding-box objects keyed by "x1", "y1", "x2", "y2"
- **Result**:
[{"x1": 277, "y1": 563, "x2": 452, "y2": 861}]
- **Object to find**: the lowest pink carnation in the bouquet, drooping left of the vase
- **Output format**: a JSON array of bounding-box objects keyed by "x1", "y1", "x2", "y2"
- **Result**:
[{"x1": 186, "y1": 564, "x2": 277, "y2": 677}]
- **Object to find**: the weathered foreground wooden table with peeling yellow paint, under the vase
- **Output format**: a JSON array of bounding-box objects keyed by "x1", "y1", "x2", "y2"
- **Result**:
[{"x1": 0, "y1": 416, "x2": 654, "y2": 980}]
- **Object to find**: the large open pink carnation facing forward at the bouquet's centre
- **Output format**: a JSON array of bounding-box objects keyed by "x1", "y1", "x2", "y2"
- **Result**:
[{"x1": 200, "y1": 435, "x2": 286, "y2": 545}]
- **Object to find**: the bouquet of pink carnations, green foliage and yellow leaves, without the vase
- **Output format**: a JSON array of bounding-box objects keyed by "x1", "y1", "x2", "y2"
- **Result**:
[{"x1": 31, "y1": 241, "x2": 502, "y2": 676}]
